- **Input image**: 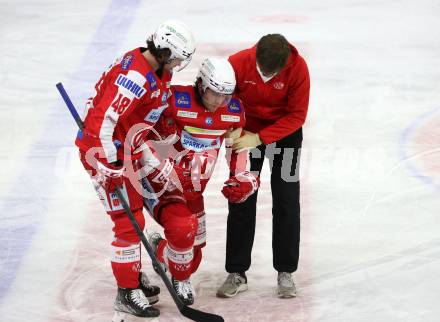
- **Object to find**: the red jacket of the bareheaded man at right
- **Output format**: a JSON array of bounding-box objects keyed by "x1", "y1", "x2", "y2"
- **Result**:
[{"x1": 229, "y1": 45, "x2": 310, "y2": 144}]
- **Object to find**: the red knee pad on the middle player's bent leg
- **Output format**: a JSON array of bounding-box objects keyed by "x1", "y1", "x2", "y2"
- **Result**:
[{"x1": 161, "y1": 203, "x2": 198, "y2": 250}]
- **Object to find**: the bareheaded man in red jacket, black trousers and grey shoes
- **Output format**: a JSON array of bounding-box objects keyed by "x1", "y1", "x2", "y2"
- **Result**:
[{"x1": 217, "y1": 34, "x2": 310, "y2": 298}]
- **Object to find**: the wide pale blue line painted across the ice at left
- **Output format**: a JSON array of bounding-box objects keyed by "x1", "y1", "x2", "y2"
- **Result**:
[{"x1": 0, "y1": 0, "x2": 140, "y2": 302}]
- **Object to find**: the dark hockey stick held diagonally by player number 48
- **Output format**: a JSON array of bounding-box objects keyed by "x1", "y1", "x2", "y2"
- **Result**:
[{"x1": 56, "y1": 83, "x2": 224, "y2": 322}]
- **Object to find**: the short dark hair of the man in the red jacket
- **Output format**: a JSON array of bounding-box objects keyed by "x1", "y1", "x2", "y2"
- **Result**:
[{"x1": 257, "y1": 34, "x2": 290, "y2": 73}]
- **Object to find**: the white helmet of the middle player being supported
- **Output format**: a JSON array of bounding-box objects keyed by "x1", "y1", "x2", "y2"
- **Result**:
[{"x1": 197, "y1": 57, "x2": 236, "y2": 95}]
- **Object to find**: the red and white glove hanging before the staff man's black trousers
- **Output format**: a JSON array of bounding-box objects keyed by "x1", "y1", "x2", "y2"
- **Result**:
[{"x1": 222, "y1": 171, "x2": 260, "y2": 203}]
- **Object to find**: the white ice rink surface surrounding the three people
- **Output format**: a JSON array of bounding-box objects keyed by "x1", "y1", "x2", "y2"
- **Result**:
[{"x1": 0, "y1": 0, "x2": 440, "y2": 322}]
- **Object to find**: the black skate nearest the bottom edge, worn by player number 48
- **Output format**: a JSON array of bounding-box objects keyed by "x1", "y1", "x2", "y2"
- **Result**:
[{"x1": 112, "y1": 288, "x2": 160, "y2": 322}]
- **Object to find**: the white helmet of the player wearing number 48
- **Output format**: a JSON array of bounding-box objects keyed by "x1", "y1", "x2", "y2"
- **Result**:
[{"x1": 151, "y1": 20, "x2": 196, "y2": 68}]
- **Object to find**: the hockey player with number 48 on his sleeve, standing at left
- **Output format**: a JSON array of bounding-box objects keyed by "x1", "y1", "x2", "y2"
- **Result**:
[{"x1": 75, "y1": 20, "x2": 195, "y2": 317}]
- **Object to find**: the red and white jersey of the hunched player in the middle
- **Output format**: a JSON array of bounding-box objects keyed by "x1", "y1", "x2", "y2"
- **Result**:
[{"x1": 160, "y1": 86, "x2": 247, "y2": 191}]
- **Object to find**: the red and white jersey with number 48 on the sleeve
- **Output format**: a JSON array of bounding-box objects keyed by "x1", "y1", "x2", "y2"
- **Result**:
[{"x1": 75, "y1": 48, "x2": 171, "y2": 163}]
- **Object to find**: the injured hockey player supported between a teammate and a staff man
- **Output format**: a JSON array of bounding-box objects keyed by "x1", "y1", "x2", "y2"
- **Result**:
[{"x1": 144, "y1": 58, "x2": 259, "y2": 304}]
